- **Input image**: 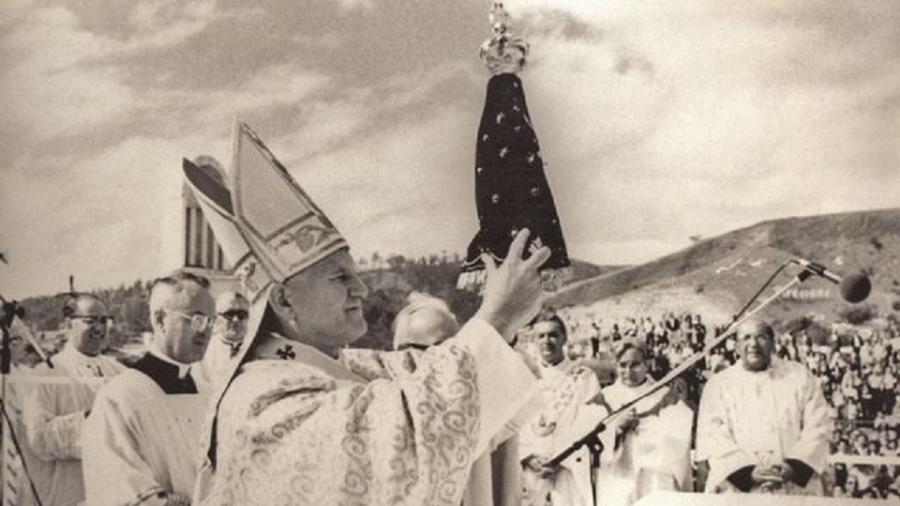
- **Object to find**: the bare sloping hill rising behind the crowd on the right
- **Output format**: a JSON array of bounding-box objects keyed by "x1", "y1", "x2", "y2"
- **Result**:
[{"x1": 549, "y1": 209, "x2": 900, "y2": 320}]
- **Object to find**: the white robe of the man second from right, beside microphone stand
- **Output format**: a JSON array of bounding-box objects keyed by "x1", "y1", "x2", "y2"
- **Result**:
[{"x1": 596, "y1": 377, "x2": 694, "y2": 506}]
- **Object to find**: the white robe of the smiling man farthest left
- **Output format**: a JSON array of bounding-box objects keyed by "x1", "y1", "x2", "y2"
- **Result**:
[{"x1": 18, "y1": 343, "x2": 125, "y2": 506}]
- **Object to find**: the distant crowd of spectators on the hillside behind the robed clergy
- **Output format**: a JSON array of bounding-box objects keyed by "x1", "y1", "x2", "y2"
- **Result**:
[{"x1": 561, "y1": 309, "x2": 900, "y2": 498}]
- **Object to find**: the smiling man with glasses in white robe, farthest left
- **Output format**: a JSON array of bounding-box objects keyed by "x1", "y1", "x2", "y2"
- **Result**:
[{"x1": 20, "y1": 293, "x2": 125, "y2": 506}]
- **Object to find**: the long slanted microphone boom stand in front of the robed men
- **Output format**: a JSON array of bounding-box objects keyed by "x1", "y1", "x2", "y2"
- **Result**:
[{"x1": 547, "y1": 260, "x2": 814, "y2": 467}]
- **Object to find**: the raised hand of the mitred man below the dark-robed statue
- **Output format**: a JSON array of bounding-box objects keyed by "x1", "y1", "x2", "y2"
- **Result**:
[{"x1": 476, "y1": 229, "x2": 550, "y2": 341}]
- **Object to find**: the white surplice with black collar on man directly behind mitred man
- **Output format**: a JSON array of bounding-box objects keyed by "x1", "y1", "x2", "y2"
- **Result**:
[{"x1": 83, "y1": 350, "x2": 209, "y2": 506}]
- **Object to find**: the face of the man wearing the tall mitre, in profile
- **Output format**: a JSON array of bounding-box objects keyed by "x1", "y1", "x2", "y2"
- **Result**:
[{"x1": 283, "y1": 250, "x2": 369, "y2": 352}]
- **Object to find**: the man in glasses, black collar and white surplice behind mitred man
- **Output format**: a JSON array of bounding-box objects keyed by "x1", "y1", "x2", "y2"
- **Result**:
[{"x1": 82, "y1": 272, "x2": 215, "y2": 506}]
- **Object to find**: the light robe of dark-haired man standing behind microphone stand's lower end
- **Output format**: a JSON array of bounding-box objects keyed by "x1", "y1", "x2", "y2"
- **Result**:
[{"x1": 519, "y1": 360, "x2": 606, "y2": 506}]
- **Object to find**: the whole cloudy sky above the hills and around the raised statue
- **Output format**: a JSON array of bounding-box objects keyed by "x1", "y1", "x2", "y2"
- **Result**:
[{"x1": 0, "y1": 0, "x2": 900, "y2": 298}]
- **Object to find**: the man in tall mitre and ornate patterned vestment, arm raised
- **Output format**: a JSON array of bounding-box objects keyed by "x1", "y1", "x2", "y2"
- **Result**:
[{"x1": 184, "y1": 124, "x2": 549, "y2": 506}]
